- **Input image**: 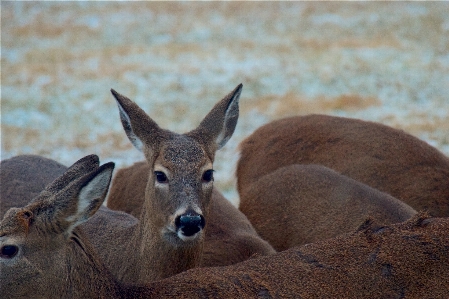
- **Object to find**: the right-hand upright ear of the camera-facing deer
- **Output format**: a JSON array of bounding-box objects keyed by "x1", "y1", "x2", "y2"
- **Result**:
[{"x1": 189, "y1": 84, "x2": 243, "y2": 150}]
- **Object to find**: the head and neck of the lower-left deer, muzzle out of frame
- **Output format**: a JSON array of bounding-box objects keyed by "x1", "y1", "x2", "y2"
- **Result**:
[{"x1": 0, "y1": 156, "x2": 118, "y2": 298}]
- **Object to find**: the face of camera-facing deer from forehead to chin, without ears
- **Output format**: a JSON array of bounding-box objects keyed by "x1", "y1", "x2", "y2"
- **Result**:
[{"x1": 146, "y1": 135, "x2": 213, "y2": 242}]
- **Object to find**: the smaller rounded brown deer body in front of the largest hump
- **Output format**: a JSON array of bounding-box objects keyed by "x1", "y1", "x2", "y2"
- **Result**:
[{"x1": 240, "y1": 164, "x2": 416, "y2": 251}]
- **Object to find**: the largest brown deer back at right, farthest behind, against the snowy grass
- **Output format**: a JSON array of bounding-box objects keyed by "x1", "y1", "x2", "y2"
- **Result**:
[{"x1": 236, "y1": 115, "x2": 449, "y2": 220}]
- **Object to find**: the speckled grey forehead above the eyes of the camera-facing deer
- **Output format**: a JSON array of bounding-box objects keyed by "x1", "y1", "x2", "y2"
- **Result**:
[{"x1": 156, "y1": 135, "x2": 212, "y2": 172}]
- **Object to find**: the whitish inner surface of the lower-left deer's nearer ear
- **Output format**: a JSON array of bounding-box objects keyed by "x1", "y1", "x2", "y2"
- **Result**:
[{"x1": 66, "y1": 169, "x2": 113, "y2": 232}]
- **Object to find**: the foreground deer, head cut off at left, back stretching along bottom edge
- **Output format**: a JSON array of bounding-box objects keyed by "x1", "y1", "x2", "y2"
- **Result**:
[{"x1": 0, "y1": 158, "x2": 449, "y2": 299}]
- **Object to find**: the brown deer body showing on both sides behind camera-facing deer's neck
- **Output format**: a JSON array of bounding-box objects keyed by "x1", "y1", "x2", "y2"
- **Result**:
[{"x1": 107, "y1": 162, "x2": 275, "y2": 267}]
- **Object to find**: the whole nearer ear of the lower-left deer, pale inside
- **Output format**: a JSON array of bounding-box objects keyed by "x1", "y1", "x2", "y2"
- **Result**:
[{"x1": 64, "y1": 162, "x2": 114, "y2": 233}]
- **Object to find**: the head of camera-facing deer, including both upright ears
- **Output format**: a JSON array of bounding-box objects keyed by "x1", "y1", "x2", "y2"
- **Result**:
[{"x1": 112, "y1": 84, "x2": 242, "y2": 245}]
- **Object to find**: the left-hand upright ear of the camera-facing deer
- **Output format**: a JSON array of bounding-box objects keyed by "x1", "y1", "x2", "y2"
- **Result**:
[{"x1": 111, "y1": 89, "x2": 160, "y2": 152}]
